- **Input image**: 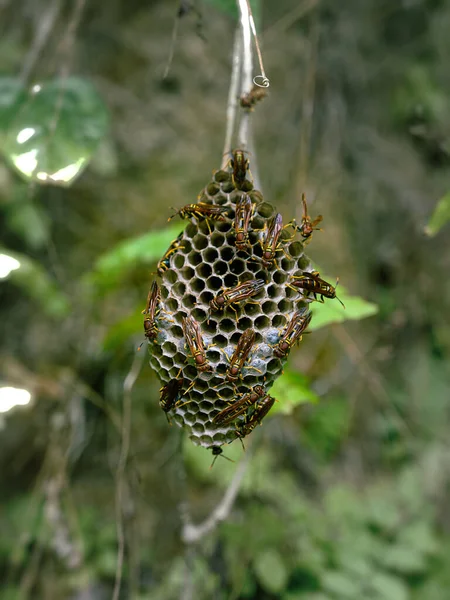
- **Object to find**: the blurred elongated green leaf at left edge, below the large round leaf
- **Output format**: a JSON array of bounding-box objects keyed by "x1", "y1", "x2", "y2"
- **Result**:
[{"x1": 0, "y1": 248, "x2": 70, "y2": 318}]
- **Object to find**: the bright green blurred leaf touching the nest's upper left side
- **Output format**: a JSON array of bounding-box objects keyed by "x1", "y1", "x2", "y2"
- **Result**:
[{"x1": 87, "y1": 225, "x2": 184, "y2": 286}]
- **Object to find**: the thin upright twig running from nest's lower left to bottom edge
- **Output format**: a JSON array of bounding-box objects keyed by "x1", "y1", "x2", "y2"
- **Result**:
[{"x1": 113, "y1": 352, "x2": 145, "y2": 600}]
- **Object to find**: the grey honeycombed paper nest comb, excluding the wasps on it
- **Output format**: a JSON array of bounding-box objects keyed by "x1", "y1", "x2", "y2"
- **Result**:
[{"x1": 149, "y1": 166, "x2": 312, "y2": 448}]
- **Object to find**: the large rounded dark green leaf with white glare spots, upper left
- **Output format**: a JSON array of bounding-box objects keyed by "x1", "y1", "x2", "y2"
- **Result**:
[{"x1": 0, "y1": 77, "x2": 108, "y2": 186}]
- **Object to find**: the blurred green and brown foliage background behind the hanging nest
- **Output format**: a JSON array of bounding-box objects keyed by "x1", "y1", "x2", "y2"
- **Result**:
[{"x1": 0, "y1": 0, "x2": 450, "y2": 600}]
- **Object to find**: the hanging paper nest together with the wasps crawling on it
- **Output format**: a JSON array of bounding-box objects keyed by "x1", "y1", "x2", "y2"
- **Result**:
[{"x1": 143, "y1": 151, "x2": 333, "y2": 454}]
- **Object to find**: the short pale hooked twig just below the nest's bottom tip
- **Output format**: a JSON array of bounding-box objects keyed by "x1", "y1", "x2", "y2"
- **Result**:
[{"x1": 181, "y1": 448, "x2": 252, "y2": 544}]
